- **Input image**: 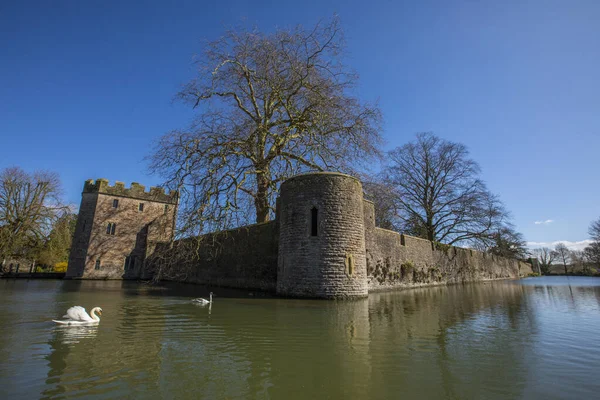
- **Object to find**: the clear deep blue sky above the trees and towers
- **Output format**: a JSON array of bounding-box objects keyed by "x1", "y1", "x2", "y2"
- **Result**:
[{"x1": 0, "y1": 0, "x2": 600, "y2": 248}]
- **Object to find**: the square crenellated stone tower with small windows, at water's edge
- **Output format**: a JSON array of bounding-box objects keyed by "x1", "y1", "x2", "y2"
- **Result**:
[{"x1": 66, "y1": 179, "x2": 178, "y2": 279}]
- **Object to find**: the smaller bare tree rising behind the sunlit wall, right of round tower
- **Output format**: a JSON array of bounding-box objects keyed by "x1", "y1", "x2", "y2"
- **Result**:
[{"x1": 385, "y1": 133, "x2": 508, "y2": 247}]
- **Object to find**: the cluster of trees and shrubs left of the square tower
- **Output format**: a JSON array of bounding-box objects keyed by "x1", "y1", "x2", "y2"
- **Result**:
[{"x1": 0, "y1": 167, "x2": 77, "y2": 272}]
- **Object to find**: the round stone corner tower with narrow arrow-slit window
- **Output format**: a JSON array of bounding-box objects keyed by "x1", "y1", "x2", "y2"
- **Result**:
[{"x1": 277, "y1": 172, "x2": 368, "y2": 298}]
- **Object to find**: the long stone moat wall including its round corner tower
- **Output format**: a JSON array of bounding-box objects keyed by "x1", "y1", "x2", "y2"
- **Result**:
[{"x1": 143, "y1": 173, "x2": 532, "y2": 298}]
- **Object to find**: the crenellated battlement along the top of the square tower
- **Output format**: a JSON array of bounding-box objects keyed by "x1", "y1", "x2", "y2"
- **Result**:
[{"x1": 83, "y1": 178, "x2": 179, "y2": 204}]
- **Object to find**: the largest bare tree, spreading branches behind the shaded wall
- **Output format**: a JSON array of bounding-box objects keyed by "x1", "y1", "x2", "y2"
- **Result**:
[{"x1": 150, "y1": 19, "x2": 381, "y2": 233}]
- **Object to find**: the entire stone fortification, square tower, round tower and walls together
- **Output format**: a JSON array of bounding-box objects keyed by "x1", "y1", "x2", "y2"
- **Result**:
[{"x1": 67, "y1": 173, "x2": 532, "y2": 298}]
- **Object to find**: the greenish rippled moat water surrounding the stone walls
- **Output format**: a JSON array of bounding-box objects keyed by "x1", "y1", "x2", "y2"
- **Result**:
[{"x1": 0, "y1": 277, "x2": 600, "y2": 399}]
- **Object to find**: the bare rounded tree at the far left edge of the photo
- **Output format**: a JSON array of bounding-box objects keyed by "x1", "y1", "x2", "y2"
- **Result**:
[{"x1": 0, "y1": 167, "x2": 67, "y2": 265}]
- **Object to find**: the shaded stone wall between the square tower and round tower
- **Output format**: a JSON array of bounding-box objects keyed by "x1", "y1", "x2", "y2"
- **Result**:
[{"x1": 150, "y1": 221, "x2": 279, "y2": 292}]
